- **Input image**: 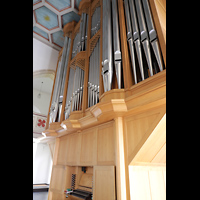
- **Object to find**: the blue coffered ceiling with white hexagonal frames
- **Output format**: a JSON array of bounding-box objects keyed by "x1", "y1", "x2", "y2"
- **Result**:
[{"x1": 33, "y1": 0, "x2": 81, "y2": 50}]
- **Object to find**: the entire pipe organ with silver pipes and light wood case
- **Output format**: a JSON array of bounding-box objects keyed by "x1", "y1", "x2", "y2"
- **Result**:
[{"x1": 43, "y1": 0, "x2": 166, "y2": 200}]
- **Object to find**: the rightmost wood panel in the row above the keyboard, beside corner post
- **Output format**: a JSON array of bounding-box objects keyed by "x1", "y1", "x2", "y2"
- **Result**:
[{"x1": 97, "y1": 121, "x2": 115, "y2": 165}]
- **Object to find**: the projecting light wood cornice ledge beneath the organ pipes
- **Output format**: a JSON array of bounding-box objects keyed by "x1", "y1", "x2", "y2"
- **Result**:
[{"x1": 43, "y1": 70, "x2": 166, "y2": 137}]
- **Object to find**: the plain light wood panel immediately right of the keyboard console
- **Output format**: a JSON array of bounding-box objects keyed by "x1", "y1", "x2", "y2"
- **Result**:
[{"x1": 93, "y1": 166, "x2": 116, "y2": 200}]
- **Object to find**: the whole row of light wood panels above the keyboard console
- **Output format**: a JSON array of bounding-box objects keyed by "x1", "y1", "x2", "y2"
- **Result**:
[{"x1": 56, "y1": 121, "x2": 115, "y2": 166}]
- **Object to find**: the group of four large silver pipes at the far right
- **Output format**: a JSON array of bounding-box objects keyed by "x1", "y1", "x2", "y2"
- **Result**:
[{"x1": 124, "y1": 0, "x2": 163, "y2": 83}]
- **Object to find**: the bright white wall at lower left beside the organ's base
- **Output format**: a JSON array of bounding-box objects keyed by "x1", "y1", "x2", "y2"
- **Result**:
[{"x1": 33, "y1": 143, "x2": 52, "y2": 184}]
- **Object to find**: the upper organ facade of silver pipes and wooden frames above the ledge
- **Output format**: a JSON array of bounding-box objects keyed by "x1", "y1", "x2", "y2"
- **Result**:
[{"x1": 47, "y1": 0, "x2": 165, "y2": 128}]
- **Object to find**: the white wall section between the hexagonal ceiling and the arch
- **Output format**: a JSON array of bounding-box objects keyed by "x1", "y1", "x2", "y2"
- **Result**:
[{"x1": 33, "y1": 38, "x2": 59, "y2": 72}]
